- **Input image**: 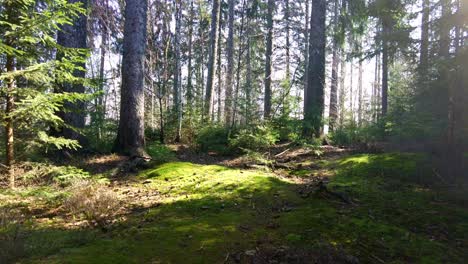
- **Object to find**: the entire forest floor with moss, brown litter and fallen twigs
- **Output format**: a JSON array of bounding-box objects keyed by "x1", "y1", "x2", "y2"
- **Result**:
[{"x1": 0, "y1": 144, "x2": 468, "y2": 263}]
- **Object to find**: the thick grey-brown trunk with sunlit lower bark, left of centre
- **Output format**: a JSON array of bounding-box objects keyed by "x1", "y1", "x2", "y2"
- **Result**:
[{"x1": 114, "y1": 0, "x2": 148, "y2": 156}]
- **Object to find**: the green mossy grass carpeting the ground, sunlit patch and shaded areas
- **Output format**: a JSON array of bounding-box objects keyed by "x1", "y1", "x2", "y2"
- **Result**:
[{"x1": 4, "y1": 154, "x2": 468, "y2": 263}]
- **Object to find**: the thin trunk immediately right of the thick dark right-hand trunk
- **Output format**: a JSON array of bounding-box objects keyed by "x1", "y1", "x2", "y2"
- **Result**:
[{"x1": 329, "y1": 0, "x2": 339, "y2": 131}]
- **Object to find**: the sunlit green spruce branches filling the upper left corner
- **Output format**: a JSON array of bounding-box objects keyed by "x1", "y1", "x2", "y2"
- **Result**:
[{"x1": 0, "y1": 0, "x2": 90, "y2": 154}]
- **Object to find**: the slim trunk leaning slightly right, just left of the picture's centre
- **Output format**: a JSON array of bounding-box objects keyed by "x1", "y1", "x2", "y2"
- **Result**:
[{"x1": 204, "y1": 0, "x2": 220, "y2": 122}]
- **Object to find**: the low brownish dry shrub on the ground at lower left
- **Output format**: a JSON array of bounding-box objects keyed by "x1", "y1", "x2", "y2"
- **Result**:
[{"x1": 64, "y1": 180, "x2": 120, "y2": 228}]
